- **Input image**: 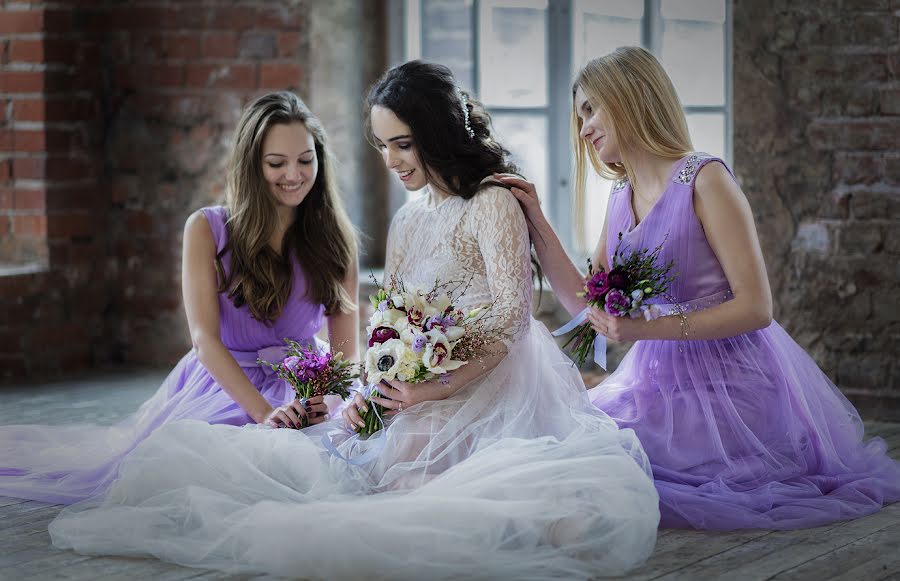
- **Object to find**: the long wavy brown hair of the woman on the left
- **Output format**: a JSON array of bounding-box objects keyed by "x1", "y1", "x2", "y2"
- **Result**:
[{"x1": 216, "y1": 91, "x2": 357, "y2": 322}]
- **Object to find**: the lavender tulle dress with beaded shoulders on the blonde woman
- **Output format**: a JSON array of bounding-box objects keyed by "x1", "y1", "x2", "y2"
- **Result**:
[{"x1": 590, "y1": 154, "x2": 900, "y2": 530}]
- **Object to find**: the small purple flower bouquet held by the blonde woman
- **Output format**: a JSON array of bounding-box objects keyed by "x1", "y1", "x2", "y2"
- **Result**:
[{"x1": 563, "y1": 233, "x2": 677, "y2": 366}]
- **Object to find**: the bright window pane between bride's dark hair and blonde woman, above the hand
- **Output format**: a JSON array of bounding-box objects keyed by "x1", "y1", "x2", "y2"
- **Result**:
[{"x1": 491, "y1": 113, "x2": 548, "y2": 204}]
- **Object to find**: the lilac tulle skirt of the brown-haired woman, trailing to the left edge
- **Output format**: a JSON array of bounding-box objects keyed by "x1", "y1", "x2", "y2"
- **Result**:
[{"x1": 0, "y1": 351, "x2": 294, "y2": 504}]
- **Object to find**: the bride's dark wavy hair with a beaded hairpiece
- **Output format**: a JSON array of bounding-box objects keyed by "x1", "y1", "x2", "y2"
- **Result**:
[{"x1": 366, "y1": 60, "x2": 518, "y2": 199}]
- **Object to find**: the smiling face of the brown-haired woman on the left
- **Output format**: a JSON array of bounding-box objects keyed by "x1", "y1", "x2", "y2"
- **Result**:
[{"x1": 262, "y1": 123, "x2": 319, "y2": 208}]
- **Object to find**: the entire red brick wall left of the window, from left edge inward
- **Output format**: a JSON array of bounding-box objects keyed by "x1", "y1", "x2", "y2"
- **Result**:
[{"x1": 0, "y1": 0, "x2": 307, "y2": 379}]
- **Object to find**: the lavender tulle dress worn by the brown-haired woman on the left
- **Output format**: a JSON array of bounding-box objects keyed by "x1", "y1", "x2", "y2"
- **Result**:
[{"x1": 0, "y1": 207, "x2": 324, "y2": 504}]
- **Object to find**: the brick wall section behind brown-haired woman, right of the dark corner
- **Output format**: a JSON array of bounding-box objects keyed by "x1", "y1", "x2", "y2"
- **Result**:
[{"x1": 106, "y1": 0, "x2": 308, "y2": 364}]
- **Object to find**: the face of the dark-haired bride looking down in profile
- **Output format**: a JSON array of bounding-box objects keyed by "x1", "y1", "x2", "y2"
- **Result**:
[{"x1": 371, "y1": 105, "x2": 428, "y2": 191}]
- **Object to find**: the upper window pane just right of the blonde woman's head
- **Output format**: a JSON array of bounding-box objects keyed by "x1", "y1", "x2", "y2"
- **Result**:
[{"x1": 661, "y1": 13, "x2": 725, "y2": 106}]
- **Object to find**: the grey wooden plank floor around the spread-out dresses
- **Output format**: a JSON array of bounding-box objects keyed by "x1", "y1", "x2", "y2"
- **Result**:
[{"x1": 0, "y1": 371, "x2": 900, "y2": 581}]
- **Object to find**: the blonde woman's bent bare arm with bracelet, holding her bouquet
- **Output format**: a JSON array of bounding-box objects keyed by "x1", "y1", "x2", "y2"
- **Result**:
[{"x1": 590, "y1": 163, "x2": 772, "y2": 341}]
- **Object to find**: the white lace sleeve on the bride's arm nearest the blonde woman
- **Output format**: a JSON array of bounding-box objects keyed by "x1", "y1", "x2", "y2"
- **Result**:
[{"x1": 470, "y1": 187, "x2": 532, "y2": 347}]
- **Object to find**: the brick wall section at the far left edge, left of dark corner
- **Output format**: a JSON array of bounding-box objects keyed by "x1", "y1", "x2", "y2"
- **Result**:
[{"x1": 0, "y1": 2, "x2": 108, "y2": 377}]
